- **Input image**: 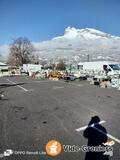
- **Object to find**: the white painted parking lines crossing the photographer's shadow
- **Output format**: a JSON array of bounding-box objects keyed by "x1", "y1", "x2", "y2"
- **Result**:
[{"x1": 76, "y1": 120, "x2": 120, "y2": 144}]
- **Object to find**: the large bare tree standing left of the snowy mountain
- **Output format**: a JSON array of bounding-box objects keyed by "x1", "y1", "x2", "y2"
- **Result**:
[{"x1": 8, "y1": 37, "x2": 35, "y2": 66}]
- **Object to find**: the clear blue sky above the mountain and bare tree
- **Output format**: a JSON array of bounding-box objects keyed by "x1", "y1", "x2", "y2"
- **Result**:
[{"x1": 0, "y1": 0, "x2": 120, "y2": 45}]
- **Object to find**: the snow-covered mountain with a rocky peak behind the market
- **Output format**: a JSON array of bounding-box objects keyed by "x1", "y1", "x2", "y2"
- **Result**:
[{"x1": 34, "y1": 27, "x2": 120, "y2": 61}]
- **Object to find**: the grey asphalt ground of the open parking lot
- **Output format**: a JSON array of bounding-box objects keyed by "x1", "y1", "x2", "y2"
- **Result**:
[{"x1": 0, "y1": 76, "x2": 120, "y2": 160}]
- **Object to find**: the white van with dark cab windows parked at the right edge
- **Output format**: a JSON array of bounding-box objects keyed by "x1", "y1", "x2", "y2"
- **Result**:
[{"x1": 78, "y1": 61, "x2": 120, "y2": 76}]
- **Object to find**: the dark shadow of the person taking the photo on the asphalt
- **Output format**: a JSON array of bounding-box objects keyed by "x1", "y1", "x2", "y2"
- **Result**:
[{"x1": 83, "y1": 116, "x2": 109, "y2": 160}]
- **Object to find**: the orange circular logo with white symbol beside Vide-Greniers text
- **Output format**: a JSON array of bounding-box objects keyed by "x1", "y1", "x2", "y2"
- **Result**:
[{"x1": 46, "y1": 140, "x2": 62, "y2": 157}]
